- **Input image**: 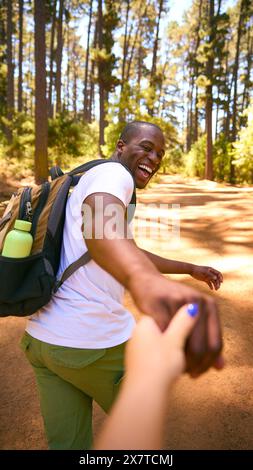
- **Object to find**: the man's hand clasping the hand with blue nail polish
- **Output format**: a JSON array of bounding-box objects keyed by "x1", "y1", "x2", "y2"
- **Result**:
[{"x1": 128, "y1": 272, "x2": 223, "y2": 376}]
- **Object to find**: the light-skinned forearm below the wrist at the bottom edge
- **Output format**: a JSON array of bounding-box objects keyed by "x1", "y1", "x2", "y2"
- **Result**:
[{"x1": 95, "y1": 380, "x2": 168, "y2": 450}]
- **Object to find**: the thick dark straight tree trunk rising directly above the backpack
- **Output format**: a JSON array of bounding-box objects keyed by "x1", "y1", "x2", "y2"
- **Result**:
[{"x1": 34, "y1": 0, "x2": 48, "y2": 183}]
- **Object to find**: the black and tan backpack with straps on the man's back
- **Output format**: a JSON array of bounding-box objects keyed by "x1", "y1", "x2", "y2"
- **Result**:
[{"x1": 0, "y1": 159, "x2": 136, "y2": 317}]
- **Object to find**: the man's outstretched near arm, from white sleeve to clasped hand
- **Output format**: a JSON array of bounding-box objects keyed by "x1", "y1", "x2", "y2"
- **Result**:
[{"x1": 84, "y1": 193, "x2": 222, "y2": 375}]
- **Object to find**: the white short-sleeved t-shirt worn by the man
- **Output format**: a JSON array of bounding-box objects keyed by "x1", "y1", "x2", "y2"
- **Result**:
[{"x1": 26, "y1": 162, "x2": 134, "y2": 349}]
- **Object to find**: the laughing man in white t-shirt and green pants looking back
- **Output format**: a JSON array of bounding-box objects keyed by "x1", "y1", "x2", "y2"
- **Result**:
[{"x1": 22, "y1": 121, "x2": 223, "y2": 449}]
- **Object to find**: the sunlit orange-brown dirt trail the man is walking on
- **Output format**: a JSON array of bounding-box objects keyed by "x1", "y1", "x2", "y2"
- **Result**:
[{"x1": 0, "y1": 176, "x2": 253, "y2": 449}]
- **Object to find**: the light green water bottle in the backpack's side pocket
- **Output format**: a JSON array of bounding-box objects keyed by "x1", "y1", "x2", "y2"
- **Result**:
[{"x1": 2, "y1": 219, "x2": 33, "y2": 258}]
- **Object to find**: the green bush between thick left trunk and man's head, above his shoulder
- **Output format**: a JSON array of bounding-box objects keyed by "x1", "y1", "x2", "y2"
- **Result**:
[{"x1": 48, "y1": 113, "x2": 98, "y2": 166}]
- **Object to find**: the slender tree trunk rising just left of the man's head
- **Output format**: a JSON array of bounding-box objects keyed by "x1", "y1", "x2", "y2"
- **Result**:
[{"x1": 98, "y1": 0, "x2": 105, "y2": 151}]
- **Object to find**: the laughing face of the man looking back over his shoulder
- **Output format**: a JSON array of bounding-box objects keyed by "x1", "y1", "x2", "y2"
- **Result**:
[{"x1": 117, "y1": 125, "x2": 165, "y2": 189}]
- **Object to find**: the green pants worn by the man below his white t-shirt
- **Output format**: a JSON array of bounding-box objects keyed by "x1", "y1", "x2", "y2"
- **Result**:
[{"x1": 21, "y1": 333, "x2": 126, "y2": 449}]
